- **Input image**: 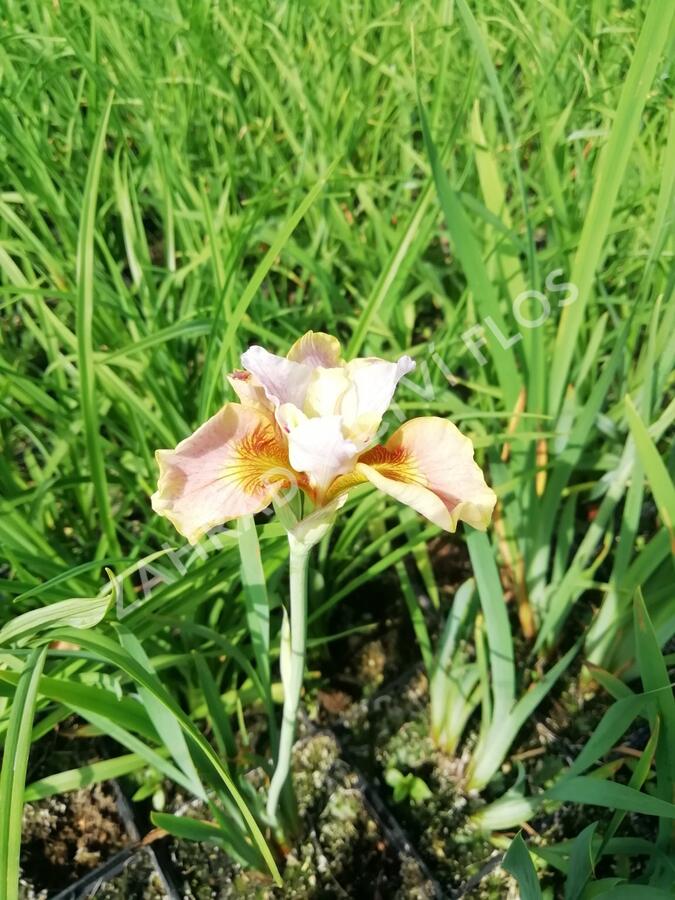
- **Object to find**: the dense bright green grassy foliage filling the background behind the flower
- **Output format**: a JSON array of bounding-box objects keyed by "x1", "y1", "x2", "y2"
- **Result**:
[{"x1": 0, "y1": 3, "x2": 669, "y2": 589}]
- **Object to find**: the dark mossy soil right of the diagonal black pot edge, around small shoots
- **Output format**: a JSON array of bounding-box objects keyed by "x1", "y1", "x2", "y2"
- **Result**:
[{"x1": 308, "y1": 541, "x2": 656, "y2": 900}]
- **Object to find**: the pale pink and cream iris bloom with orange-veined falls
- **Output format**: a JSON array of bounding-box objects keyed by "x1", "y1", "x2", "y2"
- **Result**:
[{"x1": 152, "y1": 331, "x2": 496, "y2": 544}]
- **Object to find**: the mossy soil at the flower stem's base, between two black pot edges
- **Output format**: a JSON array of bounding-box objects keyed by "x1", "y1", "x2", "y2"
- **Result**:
[{"x1": 164, "y1": 733, "x2": 433, "y2": 900}]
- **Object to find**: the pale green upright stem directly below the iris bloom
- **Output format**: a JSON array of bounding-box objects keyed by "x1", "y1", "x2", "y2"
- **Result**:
[{"x1": 267, "y1": 534, "x2": 311, "y2": 822}]
